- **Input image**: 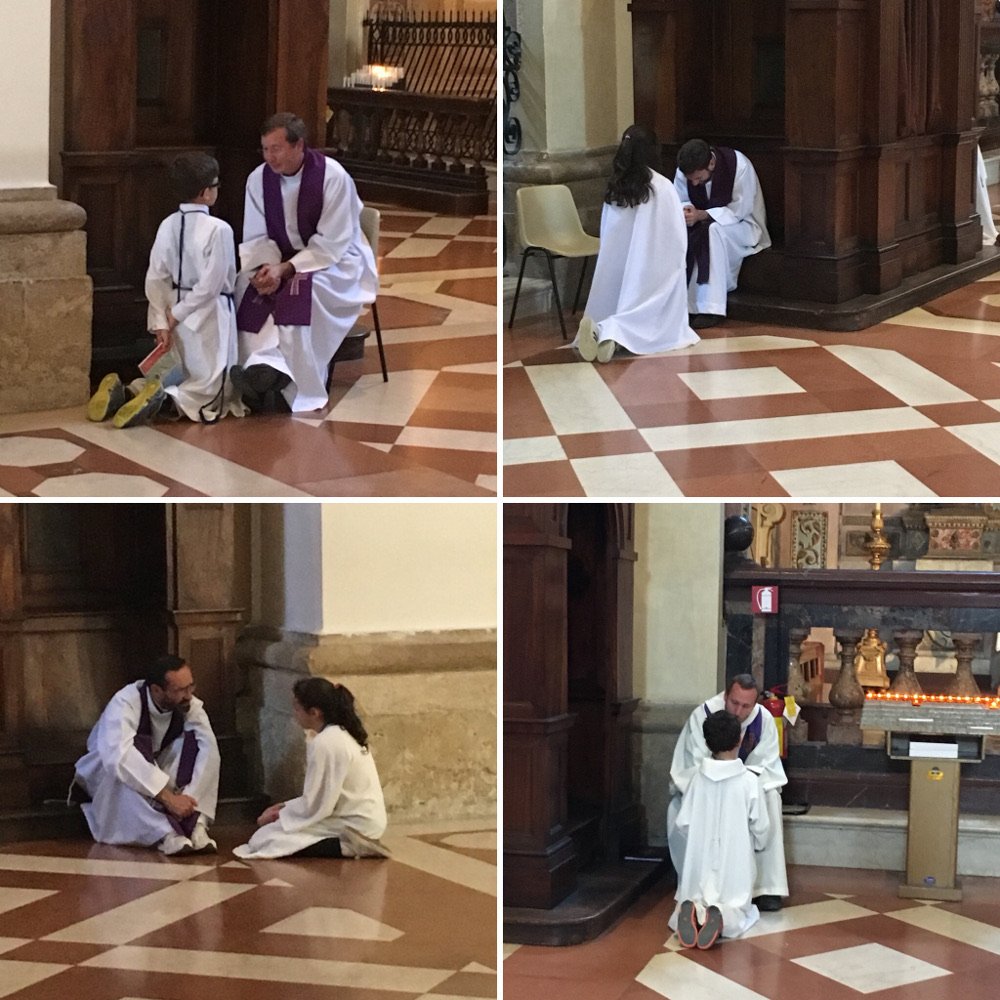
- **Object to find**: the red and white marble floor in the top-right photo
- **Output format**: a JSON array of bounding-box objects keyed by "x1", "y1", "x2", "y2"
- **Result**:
[{"x1": 503, "y1": 276, "x2": 1000, "y2": 498}]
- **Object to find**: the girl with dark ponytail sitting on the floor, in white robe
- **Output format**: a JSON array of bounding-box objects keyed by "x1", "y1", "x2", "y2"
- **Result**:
[{"x1": 233, "y1": 677, "x2": 387, "y2": 858}]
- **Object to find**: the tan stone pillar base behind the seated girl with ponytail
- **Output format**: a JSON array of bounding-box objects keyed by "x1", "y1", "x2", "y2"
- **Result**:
[{"x1": 236, "y1": 628, "x2": 497, "y2": 823}]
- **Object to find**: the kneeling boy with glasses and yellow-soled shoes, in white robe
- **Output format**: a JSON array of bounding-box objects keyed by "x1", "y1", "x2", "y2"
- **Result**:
[{"x1": 87, "y1": 153, "x2": 246, "y2": 427}]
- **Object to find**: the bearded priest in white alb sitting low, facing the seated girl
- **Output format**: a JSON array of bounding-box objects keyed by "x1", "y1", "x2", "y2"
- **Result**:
[{"x1": 70, "y1": 655, "x2": 219, "y2": 854}]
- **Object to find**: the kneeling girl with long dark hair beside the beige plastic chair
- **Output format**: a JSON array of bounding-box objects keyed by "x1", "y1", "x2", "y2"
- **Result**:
[{"x1": 576, "y1": 125, "x2": 698, "y2": 362}]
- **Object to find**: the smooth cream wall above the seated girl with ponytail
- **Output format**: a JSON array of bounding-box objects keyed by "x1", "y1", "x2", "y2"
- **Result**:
[{"x1": 253, "y1": 503, "x2": 497, "y2": 635}]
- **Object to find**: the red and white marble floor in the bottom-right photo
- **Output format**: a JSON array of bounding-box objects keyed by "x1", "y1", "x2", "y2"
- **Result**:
[{"x1": 503, "y1": 866, "x2": 1000, "y2": 1000}]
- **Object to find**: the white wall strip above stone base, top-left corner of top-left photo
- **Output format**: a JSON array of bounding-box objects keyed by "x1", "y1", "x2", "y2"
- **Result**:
[{"x1": 0, "y1": 0, "x2": 50, "y2": 189}]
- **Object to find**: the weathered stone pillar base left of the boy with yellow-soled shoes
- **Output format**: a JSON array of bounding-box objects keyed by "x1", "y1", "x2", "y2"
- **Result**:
[{"x1": 0, "y1": 189, "x2": 93, "y2": 413}]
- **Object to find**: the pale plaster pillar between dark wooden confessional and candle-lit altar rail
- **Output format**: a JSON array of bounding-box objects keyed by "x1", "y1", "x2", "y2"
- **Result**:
[{"x1": 633, "y1": 503, "x2": 725, "y2": 704}]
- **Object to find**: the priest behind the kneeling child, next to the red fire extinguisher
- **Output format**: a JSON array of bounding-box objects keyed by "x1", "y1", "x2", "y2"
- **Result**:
[{"x1": 667, "y1": 674, "x2": 788, "y2": 911}]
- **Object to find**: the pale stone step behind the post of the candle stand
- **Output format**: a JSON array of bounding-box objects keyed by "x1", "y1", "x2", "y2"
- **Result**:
[{"x1": 784, "y1": 806, "x2": 1000, "y2": 877}]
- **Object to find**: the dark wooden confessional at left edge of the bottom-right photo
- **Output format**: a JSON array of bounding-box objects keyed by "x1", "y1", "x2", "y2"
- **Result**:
[{"x1": 503, "y1": 504, "x2": 640, "y2": 908}]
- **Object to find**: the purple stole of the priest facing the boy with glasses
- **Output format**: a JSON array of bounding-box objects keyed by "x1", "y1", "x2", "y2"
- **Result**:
[{"x1": 236, "y1": 148, "x2": 326, "y2": 333}]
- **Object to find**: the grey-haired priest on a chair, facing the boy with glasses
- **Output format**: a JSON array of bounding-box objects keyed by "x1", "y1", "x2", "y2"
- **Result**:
[{"x1": 230, "y1": 112, "x2": 378, "y2": 413}]
